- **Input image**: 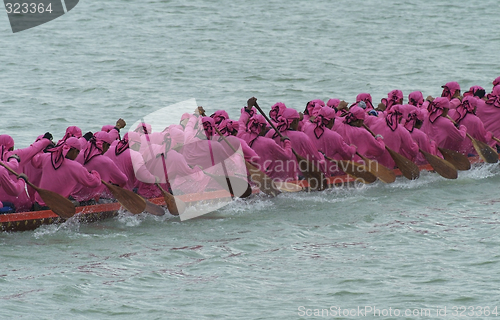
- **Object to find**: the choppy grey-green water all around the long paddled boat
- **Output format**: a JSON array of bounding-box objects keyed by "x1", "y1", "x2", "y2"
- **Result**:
[{"x1": 0, "y1": 0, "x2": 500, "y2": 319}]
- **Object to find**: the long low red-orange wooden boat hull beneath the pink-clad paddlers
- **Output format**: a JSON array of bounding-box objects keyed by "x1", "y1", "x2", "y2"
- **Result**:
[{"x1": 0, "y1": 156, "x2": 488, "y2": 231}]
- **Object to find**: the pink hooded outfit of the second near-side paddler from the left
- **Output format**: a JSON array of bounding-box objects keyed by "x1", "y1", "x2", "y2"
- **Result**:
[{"x1": 32, "y1": 137, "x2": 101, "y2": 206}]
